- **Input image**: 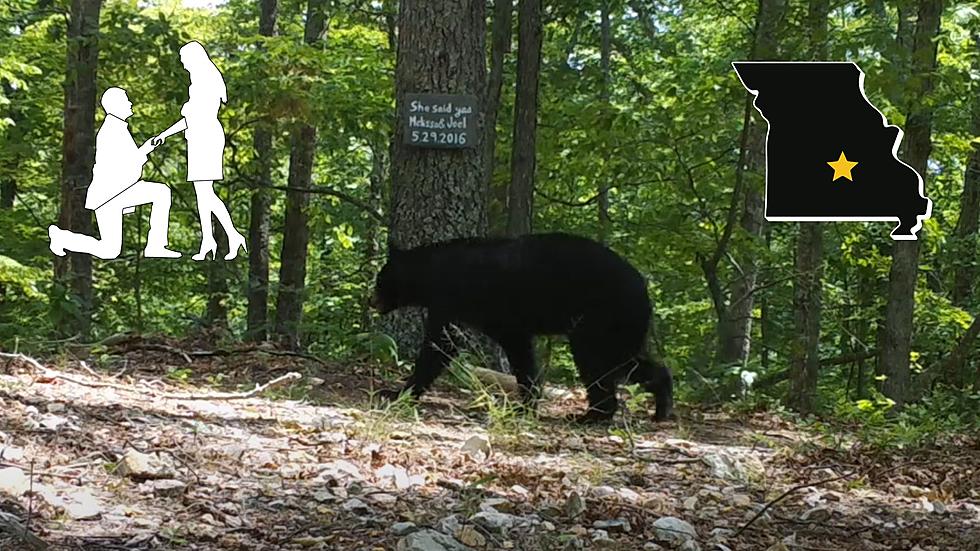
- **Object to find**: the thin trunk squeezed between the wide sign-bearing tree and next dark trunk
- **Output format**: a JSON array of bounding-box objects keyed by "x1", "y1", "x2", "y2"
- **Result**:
[{"x1": 483, "y1": 0, "x2": 512, "y2": 220}]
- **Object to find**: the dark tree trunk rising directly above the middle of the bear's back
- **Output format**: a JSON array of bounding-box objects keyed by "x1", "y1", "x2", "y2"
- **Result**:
[{"x1": 507, "y1": 0, "x2": 541, "y2": 236}]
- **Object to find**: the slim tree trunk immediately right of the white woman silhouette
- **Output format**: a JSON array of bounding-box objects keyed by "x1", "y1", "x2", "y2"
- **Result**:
[{"x1": 245, "y1": 0, "x2": 279, "y2": 342}]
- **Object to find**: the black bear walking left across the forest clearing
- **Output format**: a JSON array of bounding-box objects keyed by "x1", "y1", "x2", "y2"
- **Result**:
[{"x1": 372, "y1": 233, "x2": 673, "y2": 421}]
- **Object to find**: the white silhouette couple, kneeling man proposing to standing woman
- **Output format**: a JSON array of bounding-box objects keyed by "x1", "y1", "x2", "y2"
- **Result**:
[{"x1": 48, "y1": 42, "x2": 245, "y2": 260}]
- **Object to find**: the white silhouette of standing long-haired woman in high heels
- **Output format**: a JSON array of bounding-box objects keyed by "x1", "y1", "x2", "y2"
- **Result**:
[{"x1": 151, "y1": 42, "x2": 248, "y2": 260}]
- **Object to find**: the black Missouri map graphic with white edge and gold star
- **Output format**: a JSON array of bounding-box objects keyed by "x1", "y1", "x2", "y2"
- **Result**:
[{"x1": 732, "y1": 61, "x2": 932, "y2": 241}]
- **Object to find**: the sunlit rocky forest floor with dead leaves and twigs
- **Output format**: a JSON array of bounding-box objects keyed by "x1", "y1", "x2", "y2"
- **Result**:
[{"x1": 0, "y1": 341, "x2": 980, "y2": 551}]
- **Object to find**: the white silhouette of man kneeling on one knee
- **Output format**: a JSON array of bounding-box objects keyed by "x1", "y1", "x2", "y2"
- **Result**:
[{"x1": 48, "y1": 88, "x2": 180, "y2": 259}]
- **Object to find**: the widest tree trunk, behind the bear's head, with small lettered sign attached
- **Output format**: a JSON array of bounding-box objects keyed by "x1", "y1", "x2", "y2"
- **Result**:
[{"x1": 385, "y1": 0, "x2": 487, "y2": 355}]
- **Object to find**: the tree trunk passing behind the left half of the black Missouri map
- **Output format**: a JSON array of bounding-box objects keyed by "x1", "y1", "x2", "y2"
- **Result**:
[{"x1": 787, "y1": 0, "x2": 830, "y2": 413}]
